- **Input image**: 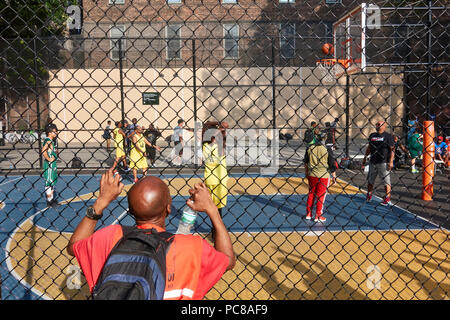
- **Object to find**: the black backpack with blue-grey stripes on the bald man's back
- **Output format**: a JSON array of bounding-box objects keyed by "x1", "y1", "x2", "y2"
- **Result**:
[{"x1": 92, "y1": 226, "x2": 173, "y2": 300}]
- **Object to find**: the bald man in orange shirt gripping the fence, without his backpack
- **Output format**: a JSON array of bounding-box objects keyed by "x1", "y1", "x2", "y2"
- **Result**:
[{"x1": 67, "y1": 169, "x2": 236, "y2": 300}]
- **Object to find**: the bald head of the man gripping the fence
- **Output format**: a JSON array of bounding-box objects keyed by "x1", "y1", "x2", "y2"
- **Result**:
[{"x1": 128, "y1": 176, "x2": 172, "y2": 227}]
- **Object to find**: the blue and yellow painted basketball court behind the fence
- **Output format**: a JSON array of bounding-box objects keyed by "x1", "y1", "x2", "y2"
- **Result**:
[{"x1": 0, "y1": 174, "x2": 450, "y2": 299}]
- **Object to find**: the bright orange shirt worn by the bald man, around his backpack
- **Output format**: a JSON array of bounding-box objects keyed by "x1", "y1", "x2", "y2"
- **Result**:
[{"x1": 73, "y1": 224, "x2": 229, "y2": 300}]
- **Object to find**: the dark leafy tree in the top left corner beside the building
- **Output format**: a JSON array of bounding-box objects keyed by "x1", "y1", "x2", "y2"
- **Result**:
[{"x1": 0, "y1": 0, "x2": 77, "y2": 129}]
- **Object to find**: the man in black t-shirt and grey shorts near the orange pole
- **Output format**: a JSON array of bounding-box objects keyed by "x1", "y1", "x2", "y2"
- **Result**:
[{"x1": 362, "y1": 121, "x2": 395, "y2": 206}]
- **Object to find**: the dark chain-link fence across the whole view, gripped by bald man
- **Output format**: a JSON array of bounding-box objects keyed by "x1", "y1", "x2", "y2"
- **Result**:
[{"x1": 0, "y1": 0, "x2": 450, "y2": 300}]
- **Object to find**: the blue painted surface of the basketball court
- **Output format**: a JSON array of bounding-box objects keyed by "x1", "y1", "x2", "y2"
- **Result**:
[{"x1": 0, "y1": 175, "x2": 437, "y2": 299}]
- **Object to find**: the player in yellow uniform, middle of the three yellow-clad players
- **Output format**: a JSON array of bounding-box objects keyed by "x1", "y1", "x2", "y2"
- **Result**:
[{"x1": 130, "y1": 125, "x2": 161, "y2": 182}]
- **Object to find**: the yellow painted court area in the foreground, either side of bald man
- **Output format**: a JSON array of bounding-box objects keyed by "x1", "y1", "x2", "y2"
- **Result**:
[{"x1": 7, "y1": 221, "x2": 450, "y2": 300}]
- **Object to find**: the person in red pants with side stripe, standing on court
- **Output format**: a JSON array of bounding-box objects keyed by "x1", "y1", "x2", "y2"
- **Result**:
[{"x1": 303, "y1": 129, "x2": 336, "y2": 222}]
